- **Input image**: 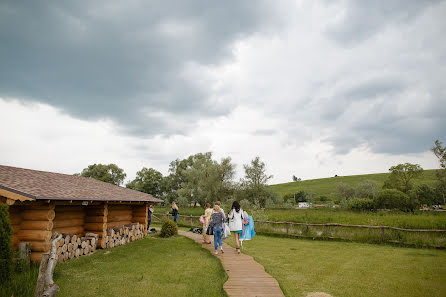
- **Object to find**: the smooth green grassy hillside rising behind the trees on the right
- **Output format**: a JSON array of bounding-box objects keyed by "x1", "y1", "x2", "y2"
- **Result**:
[{"x1": 270, "y1": 169, "x2": 436, "y2": 198}]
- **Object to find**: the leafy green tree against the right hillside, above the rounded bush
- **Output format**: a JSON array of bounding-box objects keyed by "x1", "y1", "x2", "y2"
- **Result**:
[{"x1": 383, "y1": 163, "x2": 423, "y2": 193}]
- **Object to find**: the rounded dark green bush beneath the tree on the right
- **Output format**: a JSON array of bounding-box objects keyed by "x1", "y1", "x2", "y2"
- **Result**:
[{"x1": 374, "y1": 189, "x2": 415, "y2": 211}]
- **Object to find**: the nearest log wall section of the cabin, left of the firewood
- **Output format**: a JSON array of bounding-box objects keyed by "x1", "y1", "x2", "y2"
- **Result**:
[{"x1": 18, "y1": 203, "x2": 56, "y2": 262}]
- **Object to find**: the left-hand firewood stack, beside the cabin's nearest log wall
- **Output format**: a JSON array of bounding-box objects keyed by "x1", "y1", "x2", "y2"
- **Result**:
[{"x1": 56, "y1": 233, "x2": 98, "y2": 262}]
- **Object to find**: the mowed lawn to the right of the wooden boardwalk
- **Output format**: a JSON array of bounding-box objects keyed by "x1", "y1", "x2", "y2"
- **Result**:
[{"x1": 224, "y1": 235, "x2": 446, "y2": 297}]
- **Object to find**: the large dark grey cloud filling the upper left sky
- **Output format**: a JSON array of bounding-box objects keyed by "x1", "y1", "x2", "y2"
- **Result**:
[{"x1": 0, "y1": 1, "x2": 278, "y2": 135}]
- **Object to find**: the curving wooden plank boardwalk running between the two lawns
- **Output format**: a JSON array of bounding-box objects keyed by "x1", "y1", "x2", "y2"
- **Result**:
[{"x1": 178, "y1": 230, "x2": 285, "y2": 297}]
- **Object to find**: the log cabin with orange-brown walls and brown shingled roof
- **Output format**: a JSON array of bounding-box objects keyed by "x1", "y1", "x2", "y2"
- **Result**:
[{"x1": 0, "y1": 165, "x2": 163, "y2": 261}]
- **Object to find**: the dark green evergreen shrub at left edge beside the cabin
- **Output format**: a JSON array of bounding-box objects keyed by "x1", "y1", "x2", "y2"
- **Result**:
[{"x1": 0, "y1": 204, "x2": 12, "y2": 284}]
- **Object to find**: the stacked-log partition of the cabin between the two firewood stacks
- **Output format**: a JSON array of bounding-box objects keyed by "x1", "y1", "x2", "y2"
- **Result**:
[{"x1": 84, "y1": 202, "x2": 108, "y2": 248}]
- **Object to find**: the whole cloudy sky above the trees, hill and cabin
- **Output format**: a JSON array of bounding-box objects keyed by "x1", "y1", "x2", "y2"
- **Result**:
[{"x1": 0, "y1": 0, "x2": 446, "y2": 183}]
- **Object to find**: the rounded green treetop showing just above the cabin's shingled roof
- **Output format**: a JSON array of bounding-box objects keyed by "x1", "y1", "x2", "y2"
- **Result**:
[{"x1": 77, "y1": 164, "x2": 127, "y2": 186}]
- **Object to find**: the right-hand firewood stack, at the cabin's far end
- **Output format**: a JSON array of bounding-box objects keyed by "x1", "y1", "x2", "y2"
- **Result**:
[{"x1": 105, "y1": 223, "x2": 144, "y2": 248}]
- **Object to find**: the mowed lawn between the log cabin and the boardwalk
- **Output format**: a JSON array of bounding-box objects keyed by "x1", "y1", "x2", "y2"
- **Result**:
[{"x1": 54, "y1": 235, "x2": 227, "y2": 297}]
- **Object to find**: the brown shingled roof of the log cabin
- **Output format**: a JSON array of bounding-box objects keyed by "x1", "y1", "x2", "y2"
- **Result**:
[{"x1": 0, "y1": 165, "x2": 163, "y2": 202}]
